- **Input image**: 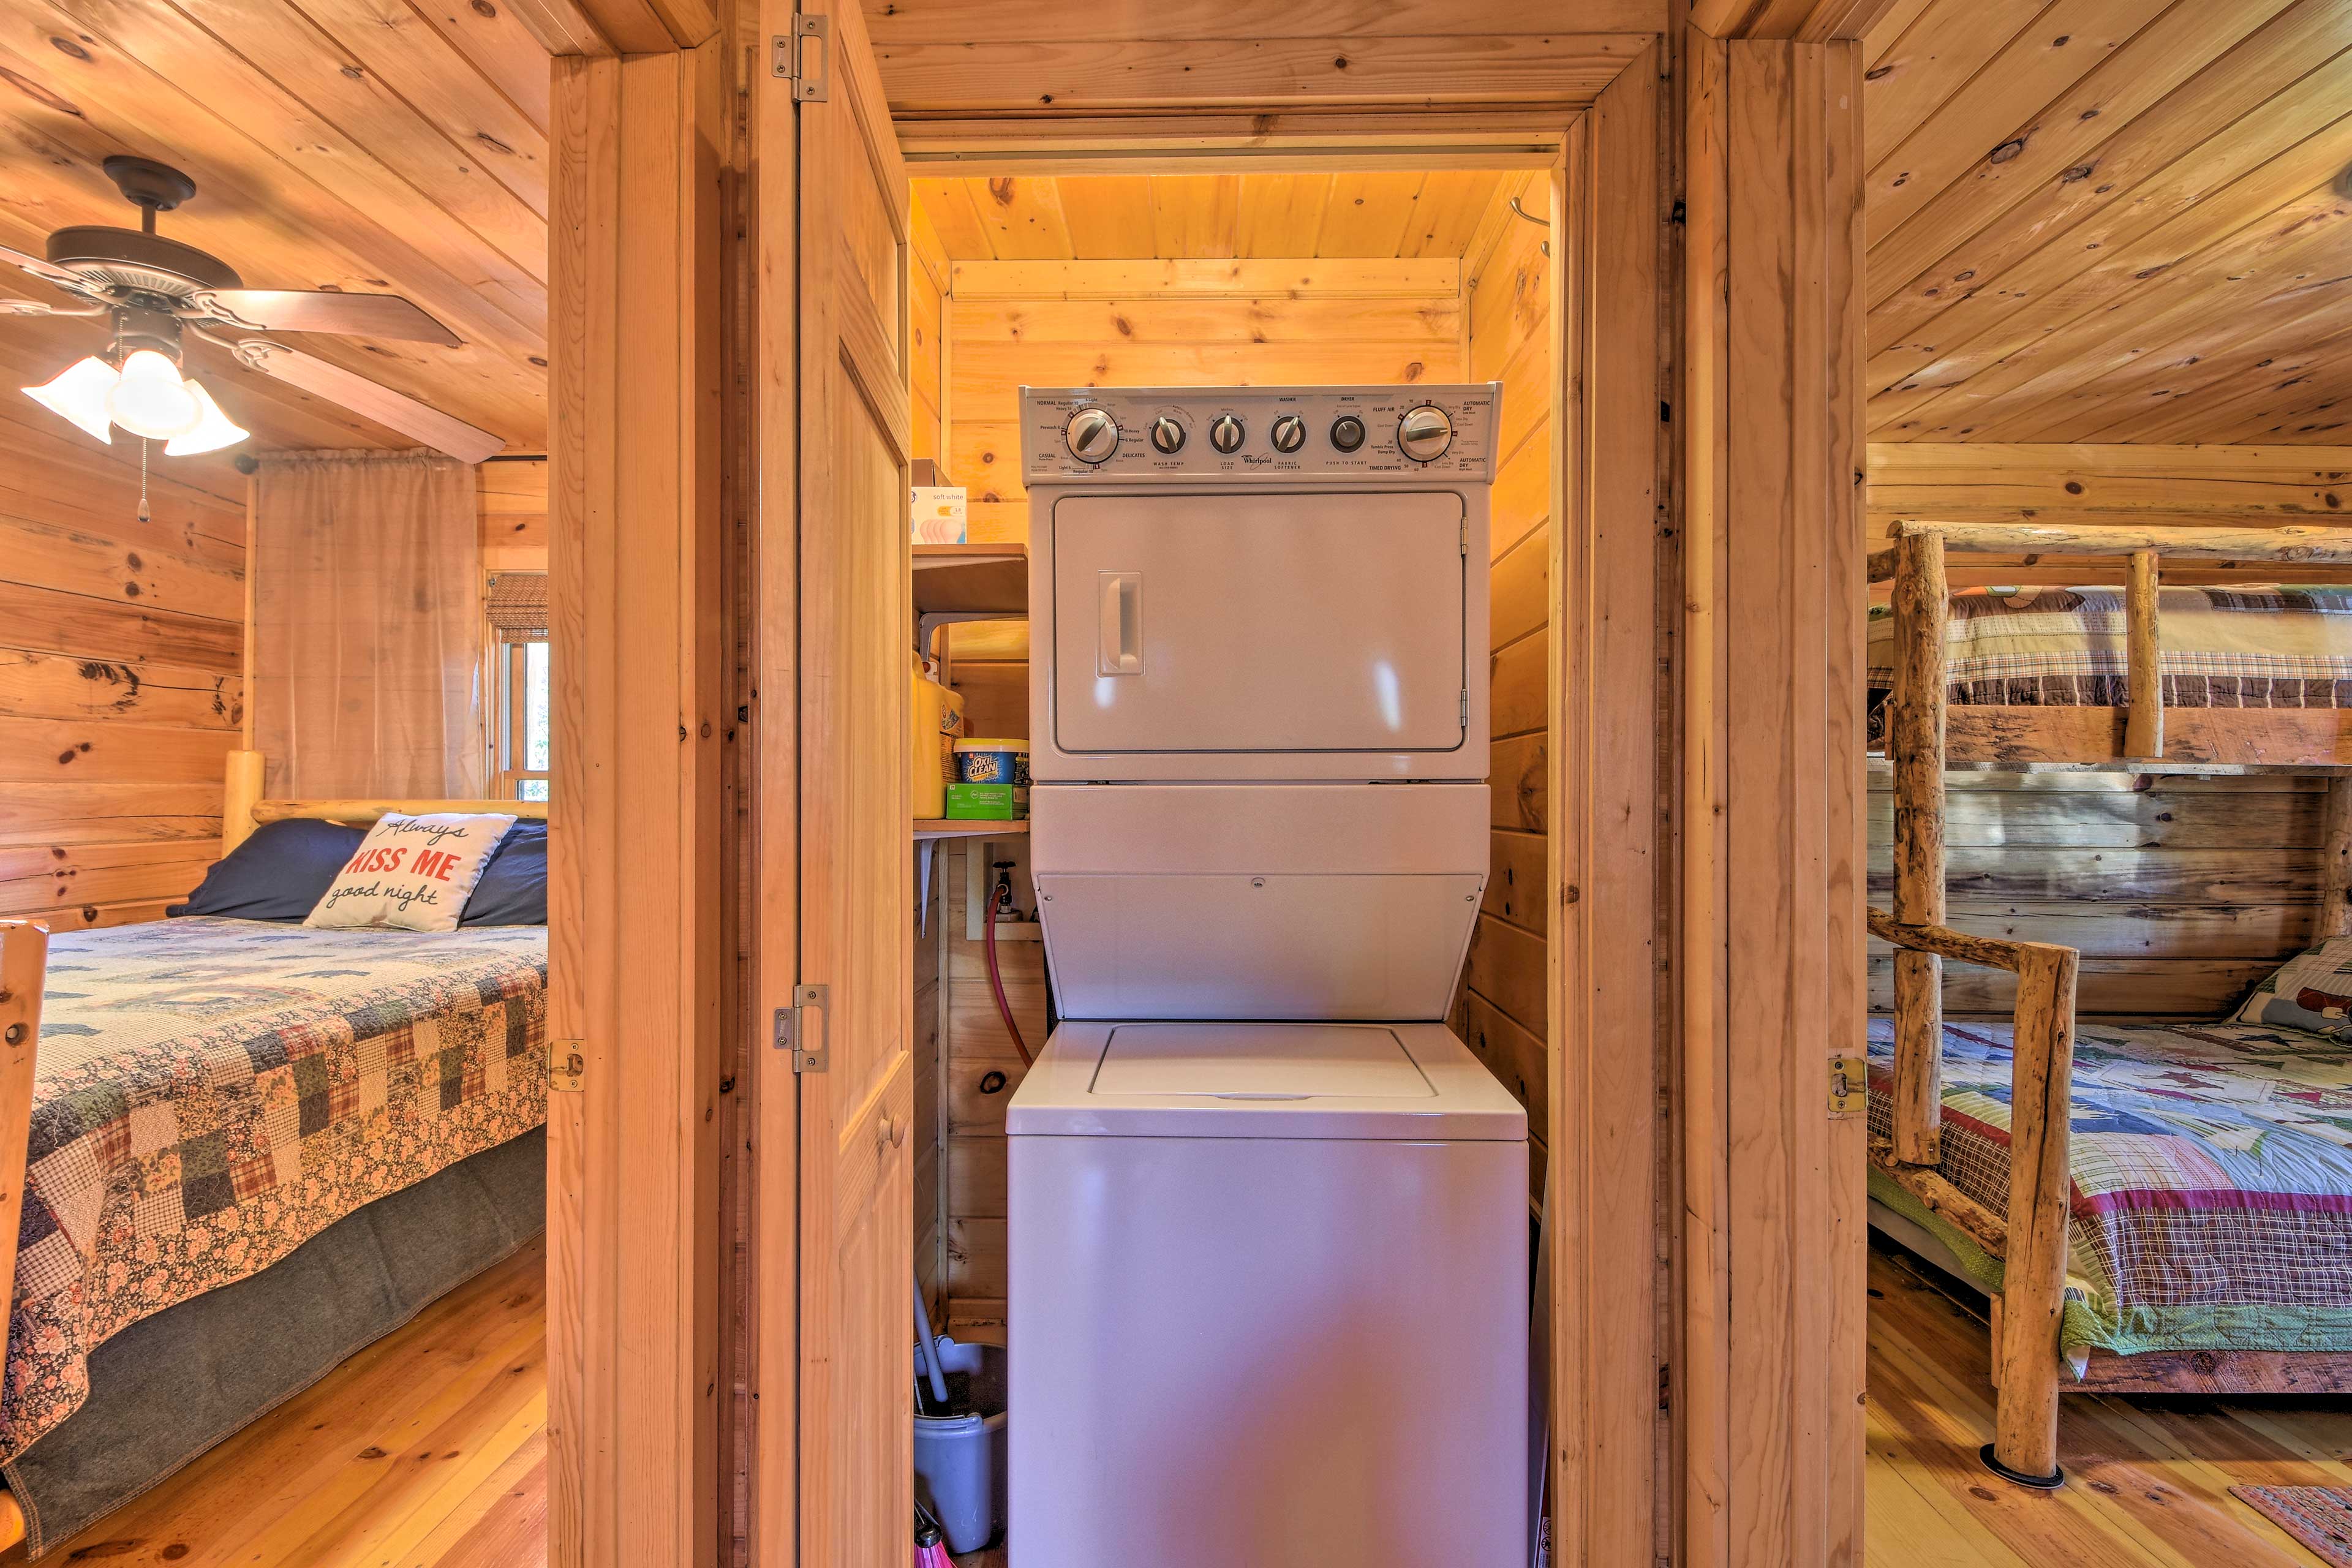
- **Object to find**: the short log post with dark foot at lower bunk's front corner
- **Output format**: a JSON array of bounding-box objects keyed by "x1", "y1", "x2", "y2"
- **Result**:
[{"x1": 1988, "y1": 945, "x2": 2077, "y2": 1486}]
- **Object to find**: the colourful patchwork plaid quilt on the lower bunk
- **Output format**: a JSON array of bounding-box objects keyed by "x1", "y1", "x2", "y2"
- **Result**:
[{"x1": 1870, "y1": 1018, "x2": 2352, "y2": 1368}]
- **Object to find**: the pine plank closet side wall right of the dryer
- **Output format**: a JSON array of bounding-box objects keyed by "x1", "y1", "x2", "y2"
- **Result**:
[{"x1": 1451, "y1": 172, "x2": 1552, "y2": 1201}]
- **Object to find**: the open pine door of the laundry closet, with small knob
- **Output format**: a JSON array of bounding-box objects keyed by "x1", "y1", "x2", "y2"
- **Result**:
[{"x1": 799, "y1": 0, "x2": 915, "y2": 1568}]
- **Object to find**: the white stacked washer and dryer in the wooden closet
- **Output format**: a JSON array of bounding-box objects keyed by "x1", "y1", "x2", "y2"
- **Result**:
[{"x1": 1007, "y1": 383, "x2": 1529, "y2": 1568}]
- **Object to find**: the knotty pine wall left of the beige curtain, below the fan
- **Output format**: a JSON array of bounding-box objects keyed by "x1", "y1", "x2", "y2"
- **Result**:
[{"x1": 0, "y1": 399, "x2": 244, "y2": 929}]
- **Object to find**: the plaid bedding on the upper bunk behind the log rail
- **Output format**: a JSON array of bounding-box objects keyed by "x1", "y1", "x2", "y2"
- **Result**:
[{"x1": 1865, "y1": 586, "x2": 2352, "y2": 741}]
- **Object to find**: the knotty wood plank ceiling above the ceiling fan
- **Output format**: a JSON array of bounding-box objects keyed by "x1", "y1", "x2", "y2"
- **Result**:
[{"x1": 0, "y1": 0, "x2": 551, "y2": 451}]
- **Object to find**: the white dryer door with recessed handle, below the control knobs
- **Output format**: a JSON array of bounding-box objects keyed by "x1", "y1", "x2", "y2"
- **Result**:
[{"x1": 1051, "y1": 491, "x2": 1449, "y2": 755}]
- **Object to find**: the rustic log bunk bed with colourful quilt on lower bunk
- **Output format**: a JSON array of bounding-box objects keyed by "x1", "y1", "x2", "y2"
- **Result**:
[{"x1": 1868, "y1": 522, "x2": 2352, "y2": 1486}]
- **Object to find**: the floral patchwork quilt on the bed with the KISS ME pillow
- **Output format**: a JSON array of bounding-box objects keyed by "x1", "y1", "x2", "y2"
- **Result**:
[{"x1": 0, "y1": 919, "x2": 548, "y2": 1462}]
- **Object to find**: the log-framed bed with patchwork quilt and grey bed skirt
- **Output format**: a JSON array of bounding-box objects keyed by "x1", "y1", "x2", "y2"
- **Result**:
[{"x1": 0, "y1": 752, "x2": 548, "y2": 1556}]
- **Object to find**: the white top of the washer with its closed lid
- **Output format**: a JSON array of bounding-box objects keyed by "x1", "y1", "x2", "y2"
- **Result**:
[{"x1": 1005, "y1": 1020, "x2": 1526, "y2": 1142}]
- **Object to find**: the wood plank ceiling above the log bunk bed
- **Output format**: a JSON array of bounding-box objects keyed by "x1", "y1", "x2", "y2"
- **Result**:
[{"x1": 1863, "y1": 0, "x2": 2352, "y2": 444}]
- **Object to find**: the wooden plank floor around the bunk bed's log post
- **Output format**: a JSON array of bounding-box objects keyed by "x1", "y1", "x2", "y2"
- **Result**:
[{"x1": 1868, "y1": 1248, "x2": 2352, "y2": 1568}]
